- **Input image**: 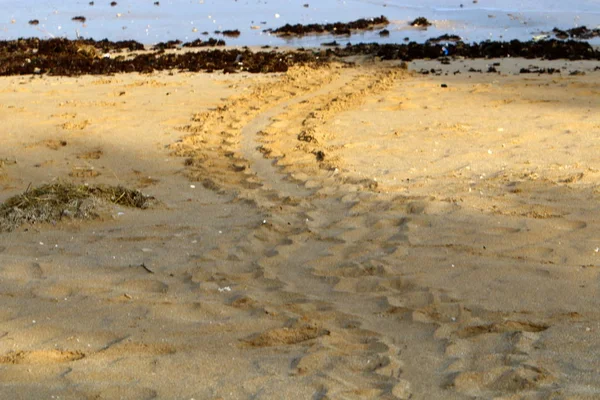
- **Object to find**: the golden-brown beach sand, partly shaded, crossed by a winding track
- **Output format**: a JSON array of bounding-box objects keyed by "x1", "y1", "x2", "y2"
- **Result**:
[{"x1": 0, "y1": 60, "x2": 600, "y2": 399}]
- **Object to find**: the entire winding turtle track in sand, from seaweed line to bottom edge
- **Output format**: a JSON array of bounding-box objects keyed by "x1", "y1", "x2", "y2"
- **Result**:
[{"x1": 172, "y1": 65, "x2": 592, "y2": 399}]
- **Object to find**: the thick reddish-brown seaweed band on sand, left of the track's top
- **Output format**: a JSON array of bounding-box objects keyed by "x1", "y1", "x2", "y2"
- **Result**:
[{"x1": 0, "y1": 39, "x2": 326, "y2": 76}]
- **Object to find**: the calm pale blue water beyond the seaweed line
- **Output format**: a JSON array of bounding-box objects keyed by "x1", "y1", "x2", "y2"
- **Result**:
[{"x1": 0, "y1": 0, "x2": 600, "y2": 46}]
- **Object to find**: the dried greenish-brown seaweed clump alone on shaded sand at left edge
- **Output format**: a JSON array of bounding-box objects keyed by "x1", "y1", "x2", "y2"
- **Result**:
[{"x1": 0, "y1": 183, "x2": 154, "y2": 232}]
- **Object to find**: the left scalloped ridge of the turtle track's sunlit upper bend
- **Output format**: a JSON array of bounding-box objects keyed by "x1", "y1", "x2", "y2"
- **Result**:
[{"x1": 171, "y1": 66, "x2": 339, "y2": 195}]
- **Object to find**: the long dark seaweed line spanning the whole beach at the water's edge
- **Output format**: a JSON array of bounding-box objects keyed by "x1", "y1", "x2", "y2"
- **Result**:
[{"x1": 0, "y1": 39, "x2": 600, "y2": 76}]
